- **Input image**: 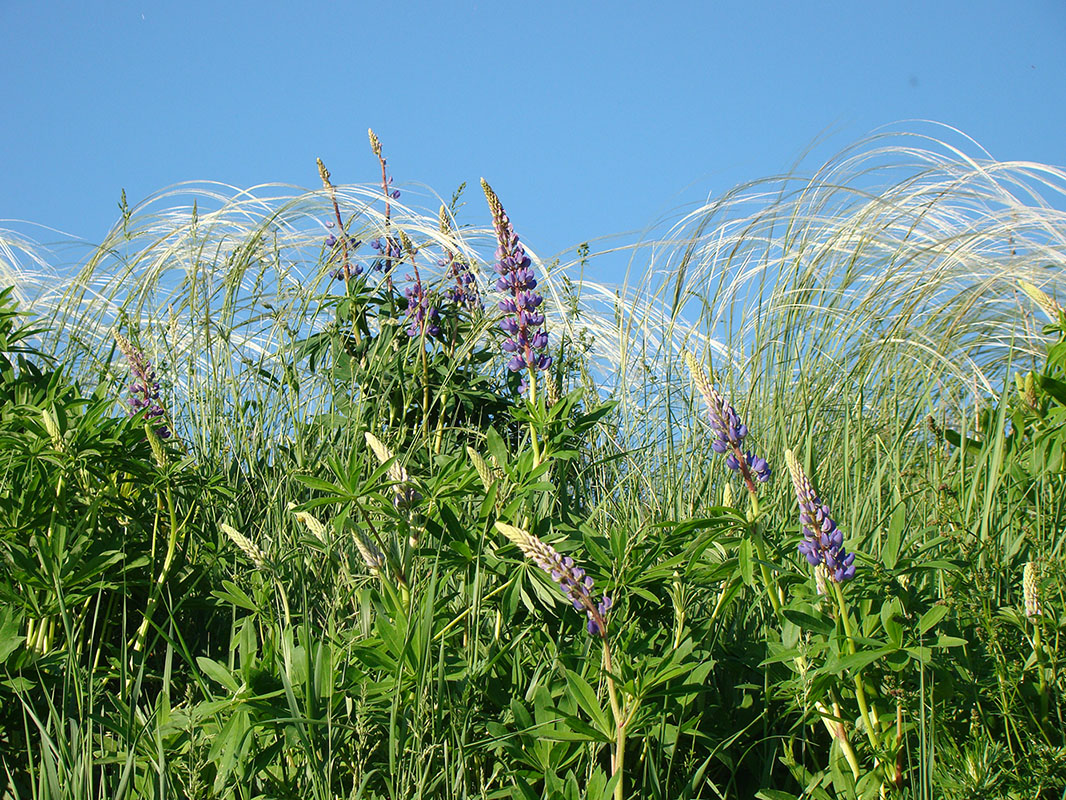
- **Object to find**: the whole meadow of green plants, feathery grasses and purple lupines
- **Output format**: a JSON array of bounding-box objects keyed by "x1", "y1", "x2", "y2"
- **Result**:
[{"x1": 0, "y1": 134, "x2": 1066, "y2": 800}]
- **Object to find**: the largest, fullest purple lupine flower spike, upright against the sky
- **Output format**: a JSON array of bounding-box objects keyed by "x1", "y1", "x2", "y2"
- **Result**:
[{"x1": 481, "y1": 178, "x2": 551, "y2": 394}]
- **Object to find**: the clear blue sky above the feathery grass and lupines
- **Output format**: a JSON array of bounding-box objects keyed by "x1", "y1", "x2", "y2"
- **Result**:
[{"x1": 0, "y1": 0, "x2": 1066, "y2": 277}]
